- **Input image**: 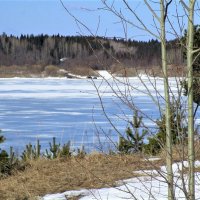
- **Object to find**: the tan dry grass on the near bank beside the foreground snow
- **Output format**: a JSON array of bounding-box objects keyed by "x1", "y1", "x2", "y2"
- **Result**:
[{"x1": 0, "y1": 154, "x2": 164, "y2": 200}]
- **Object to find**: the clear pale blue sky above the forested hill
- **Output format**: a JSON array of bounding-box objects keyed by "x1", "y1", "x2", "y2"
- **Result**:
[{"x1": 0, "y1": 0, "x2": 195, "y2": 41}]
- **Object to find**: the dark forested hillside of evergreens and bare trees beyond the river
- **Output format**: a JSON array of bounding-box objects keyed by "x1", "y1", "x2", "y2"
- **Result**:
[{"x1": 0, "y1": 34, "x2": 183, "y2": 68}]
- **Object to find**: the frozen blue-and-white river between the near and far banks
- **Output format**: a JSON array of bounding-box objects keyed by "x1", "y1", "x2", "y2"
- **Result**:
[{"x1": 0, "y1": 77, "x2": 180, "y2": 151}]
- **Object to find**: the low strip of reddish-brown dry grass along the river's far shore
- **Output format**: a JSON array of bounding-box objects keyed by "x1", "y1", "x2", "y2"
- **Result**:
[{"x1": 0, "y1": 64, "x2": 185, "y2": 78}]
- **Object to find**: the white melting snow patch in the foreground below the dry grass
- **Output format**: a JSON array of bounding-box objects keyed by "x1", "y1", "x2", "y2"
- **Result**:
[{"x1": 42, "y1": 161, "x2": 200, "y2": 200}]
